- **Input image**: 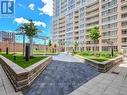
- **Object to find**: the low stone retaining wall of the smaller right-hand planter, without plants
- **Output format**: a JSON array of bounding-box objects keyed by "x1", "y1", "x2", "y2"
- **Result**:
[{"x1": 75, "y1": 55, "x2": 123, "y2": 73}]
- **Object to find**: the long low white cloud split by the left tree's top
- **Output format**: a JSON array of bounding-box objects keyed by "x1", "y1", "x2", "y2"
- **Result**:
[{"x1": 14, "y1": 17, "x2": 46, "y2": 28}]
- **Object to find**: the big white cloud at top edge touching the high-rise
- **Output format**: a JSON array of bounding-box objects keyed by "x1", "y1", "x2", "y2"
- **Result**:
[{"x1": 38, "y1": 0, "x2": 53, "y2": 16}]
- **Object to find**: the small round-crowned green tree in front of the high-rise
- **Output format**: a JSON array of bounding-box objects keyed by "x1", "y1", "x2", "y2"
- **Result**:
[{"x1": 89, "y1": 27, "x2": 100, "y2": 54}]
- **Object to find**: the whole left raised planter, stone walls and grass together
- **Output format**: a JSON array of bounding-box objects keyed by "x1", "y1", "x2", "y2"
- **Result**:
[{"x1": 0, "y1": 54, "x2": 52, "y2": 91}]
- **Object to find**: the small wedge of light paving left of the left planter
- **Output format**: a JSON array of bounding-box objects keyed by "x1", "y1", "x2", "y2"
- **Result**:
[{"x1": 0, "y1": 65, "x2": 23, "y2": 95}]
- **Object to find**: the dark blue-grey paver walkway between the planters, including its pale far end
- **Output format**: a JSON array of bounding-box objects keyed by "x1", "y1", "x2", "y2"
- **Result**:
[{"x1": 23, "y1": 53, "x2": 100, "y2": 95}]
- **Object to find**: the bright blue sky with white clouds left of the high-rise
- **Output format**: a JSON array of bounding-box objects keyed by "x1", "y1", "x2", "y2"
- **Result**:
[{"x1": 0, "y1": 0, "x2": 53, "y2": 43}]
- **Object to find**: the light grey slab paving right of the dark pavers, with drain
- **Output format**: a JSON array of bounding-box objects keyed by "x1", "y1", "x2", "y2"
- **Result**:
[{"x1": 69, "y1": 56, "x2": 127, "y2": 95}]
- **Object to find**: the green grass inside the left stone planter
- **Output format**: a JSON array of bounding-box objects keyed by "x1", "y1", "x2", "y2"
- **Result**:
[{"x1": 1, "y1": 54, "x2": 46, "y2": 68}]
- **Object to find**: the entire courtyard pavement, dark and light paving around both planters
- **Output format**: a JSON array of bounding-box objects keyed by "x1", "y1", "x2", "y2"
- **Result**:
[{"x1": 0, "y1": 53, "x2": 127, "y2": 95}]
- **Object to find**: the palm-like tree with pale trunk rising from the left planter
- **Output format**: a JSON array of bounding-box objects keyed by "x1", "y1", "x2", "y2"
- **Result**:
[{"x1": 19, "y1": 20, "x2": 40, "y2": 56}]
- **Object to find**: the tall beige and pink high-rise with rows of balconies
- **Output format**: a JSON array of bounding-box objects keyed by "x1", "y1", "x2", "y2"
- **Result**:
[{"x1": 52, "y1": 0, "x2": 127, "y2": 52}]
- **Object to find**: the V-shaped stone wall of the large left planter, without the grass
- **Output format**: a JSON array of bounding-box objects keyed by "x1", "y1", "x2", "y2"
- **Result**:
[{"x1": 0, "y1": 55, "x2": 52, "y2": 91}]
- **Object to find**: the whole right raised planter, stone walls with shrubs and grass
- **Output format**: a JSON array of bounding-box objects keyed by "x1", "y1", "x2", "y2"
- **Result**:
[{"x1": 75, "y1": 52, "x2": 123, "y2": 72}]
